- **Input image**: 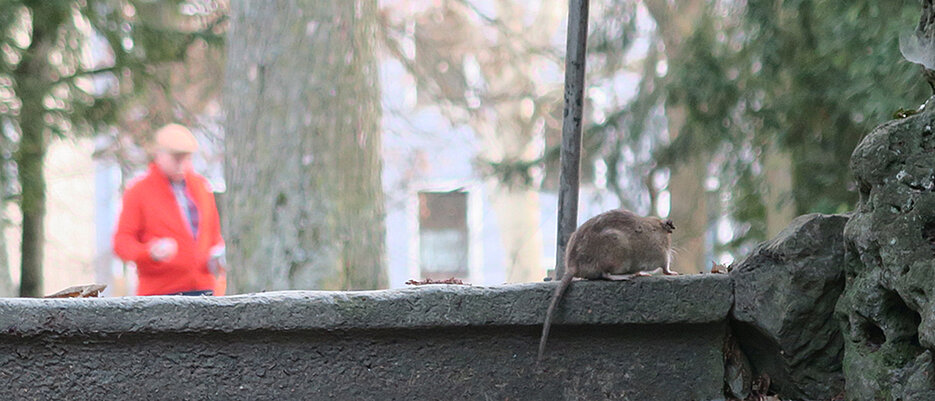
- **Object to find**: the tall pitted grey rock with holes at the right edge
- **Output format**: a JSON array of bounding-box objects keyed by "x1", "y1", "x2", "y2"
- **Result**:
[{"x1": 836, "y1": 113, "x2": 935, "y2": 400}]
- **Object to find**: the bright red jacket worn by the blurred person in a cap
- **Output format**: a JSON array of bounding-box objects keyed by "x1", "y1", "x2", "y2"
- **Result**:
[{"x1": 114, "y1": 164, "x2": 224, "y2": 295}]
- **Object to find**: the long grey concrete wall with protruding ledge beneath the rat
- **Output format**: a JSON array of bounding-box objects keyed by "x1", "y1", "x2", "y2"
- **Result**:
[{"x1": 0, "y1": 275, "x2": 732, "y2": 400}]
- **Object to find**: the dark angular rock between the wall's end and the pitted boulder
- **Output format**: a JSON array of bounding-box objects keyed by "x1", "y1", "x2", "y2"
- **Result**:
[{"x1": 730, "y1": 214, "x2": 848, "y2": 400}]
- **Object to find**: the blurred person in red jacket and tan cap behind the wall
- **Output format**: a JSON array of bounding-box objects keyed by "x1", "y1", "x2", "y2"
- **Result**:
[{"x1": 113, "y1": 124, "x2": 226, "y2": 295}]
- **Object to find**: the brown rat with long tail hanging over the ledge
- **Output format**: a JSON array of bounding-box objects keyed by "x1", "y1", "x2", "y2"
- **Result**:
[{"x1": 538, "y1": 209, "x2": 678, "y2": 361}]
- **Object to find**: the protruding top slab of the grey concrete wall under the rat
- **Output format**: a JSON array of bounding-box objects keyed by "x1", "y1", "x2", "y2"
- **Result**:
[{"x1": 0, "y1": 274, "x2": 733, "y2": 337}]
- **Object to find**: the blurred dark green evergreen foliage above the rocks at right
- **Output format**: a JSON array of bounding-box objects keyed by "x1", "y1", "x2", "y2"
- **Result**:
[{"x1": 656, "y1": 0, "x2": 931, "y2": 255}]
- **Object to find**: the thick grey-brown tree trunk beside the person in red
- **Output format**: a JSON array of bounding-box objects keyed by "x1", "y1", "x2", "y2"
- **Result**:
[{"x1": 222, "y1": 0, "x2": 387, "y2": 292}]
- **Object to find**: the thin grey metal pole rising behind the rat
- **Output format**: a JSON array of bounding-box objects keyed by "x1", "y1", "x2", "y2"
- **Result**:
[{"x1": 555, "y1": 0, "x2": 590, "y2": 279}]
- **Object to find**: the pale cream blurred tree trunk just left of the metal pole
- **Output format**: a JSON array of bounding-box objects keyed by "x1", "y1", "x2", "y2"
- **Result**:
[{"x1": 471, "y1": 0, "x2": 562, "y2": 283}]
